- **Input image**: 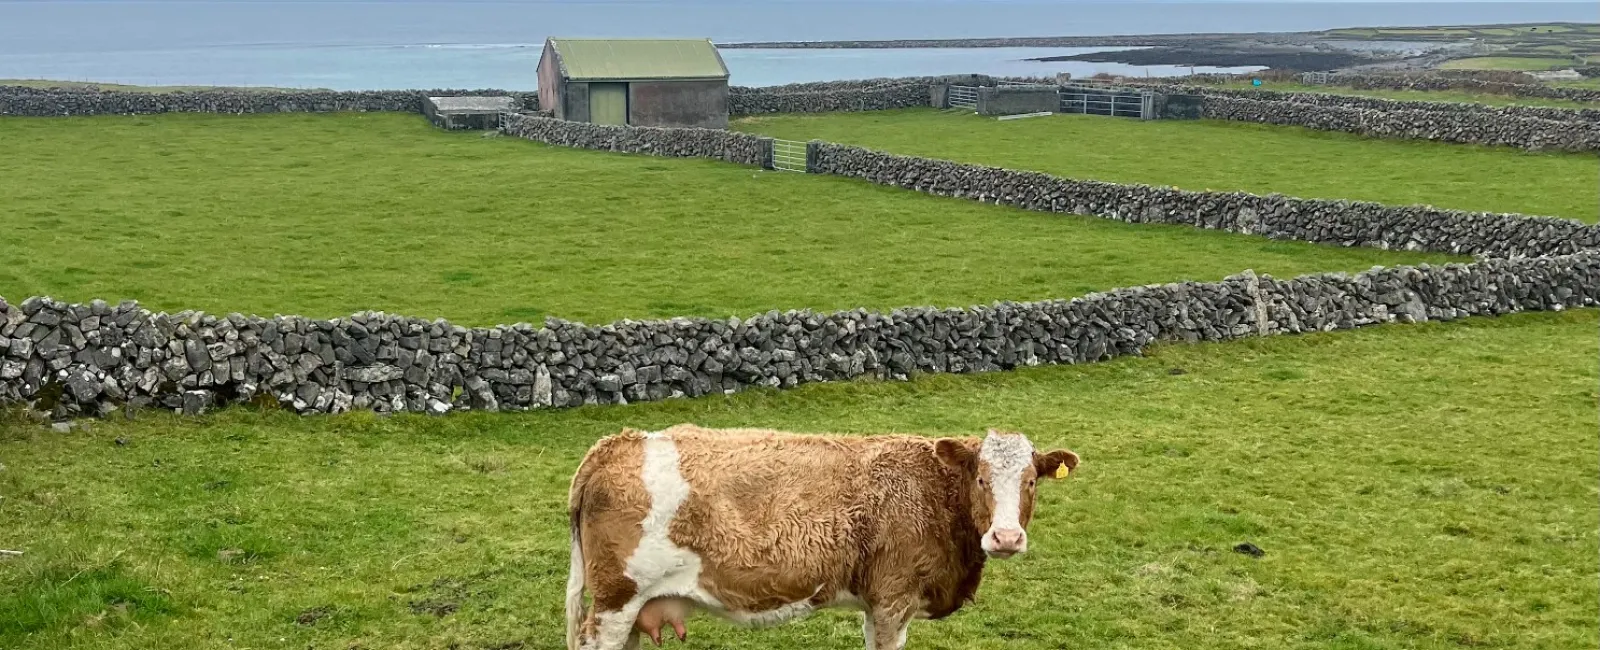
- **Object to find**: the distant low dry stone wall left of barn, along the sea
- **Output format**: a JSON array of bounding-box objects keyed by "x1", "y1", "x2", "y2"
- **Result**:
[{"x1": 0, "y1": 86, "x2": 539, "y2": 117}]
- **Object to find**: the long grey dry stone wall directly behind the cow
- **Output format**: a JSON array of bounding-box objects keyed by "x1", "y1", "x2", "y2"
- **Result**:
[{"x1": 0, "y1": 253, "x2": 1600, "y2": 418}]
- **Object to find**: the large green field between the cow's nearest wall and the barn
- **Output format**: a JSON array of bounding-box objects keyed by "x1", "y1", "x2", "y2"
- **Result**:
[{"x1": 0, "y1": 114, "x2": 1453, "y2": 325}]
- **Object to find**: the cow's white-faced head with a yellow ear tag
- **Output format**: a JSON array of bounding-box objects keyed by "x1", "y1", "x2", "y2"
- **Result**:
[{"x1": 936, "y1": 429, "x2": 1078, "y2": 559}]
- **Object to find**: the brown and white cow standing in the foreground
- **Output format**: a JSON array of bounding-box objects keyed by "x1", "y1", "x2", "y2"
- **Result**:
[{"x1": 566, "y1": 424, "x2": 1078, "y2": 650}]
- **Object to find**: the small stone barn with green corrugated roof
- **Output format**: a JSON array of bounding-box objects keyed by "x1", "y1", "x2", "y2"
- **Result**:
[{"x1": 539, "y1": 38, "x2": 728, "y2": 128}]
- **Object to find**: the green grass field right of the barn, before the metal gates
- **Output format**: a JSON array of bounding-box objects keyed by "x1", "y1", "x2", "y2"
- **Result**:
[{"x1": 734, "y1": 109, "x2": 1600, "y2": 223}]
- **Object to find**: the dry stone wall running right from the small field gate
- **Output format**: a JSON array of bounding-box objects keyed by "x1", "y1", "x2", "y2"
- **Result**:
[{"x1": 813, "y1": 142, "x2": 1600, "y2": 258}]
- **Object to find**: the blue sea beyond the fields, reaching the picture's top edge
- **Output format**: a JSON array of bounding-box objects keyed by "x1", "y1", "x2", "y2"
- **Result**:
[{"x1": 0, "y1": 0, "x2": 1600, "y2": 90}]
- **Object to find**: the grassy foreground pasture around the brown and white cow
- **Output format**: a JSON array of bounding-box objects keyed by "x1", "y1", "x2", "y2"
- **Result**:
[{"x1": 0, "y1": 311, "x2": 1600, "y2": 650}]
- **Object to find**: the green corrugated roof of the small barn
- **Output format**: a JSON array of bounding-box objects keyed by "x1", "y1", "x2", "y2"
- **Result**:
[{"x1": 550, "y1": 38, "x2": 728, "y2": 82}]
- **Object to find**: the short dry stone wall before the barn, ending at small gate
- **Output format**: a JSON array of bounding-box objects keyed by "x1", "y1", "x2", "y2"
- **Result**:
[{"x1": 501, "y1": 114, "x2": 773, "y2": 167}]
